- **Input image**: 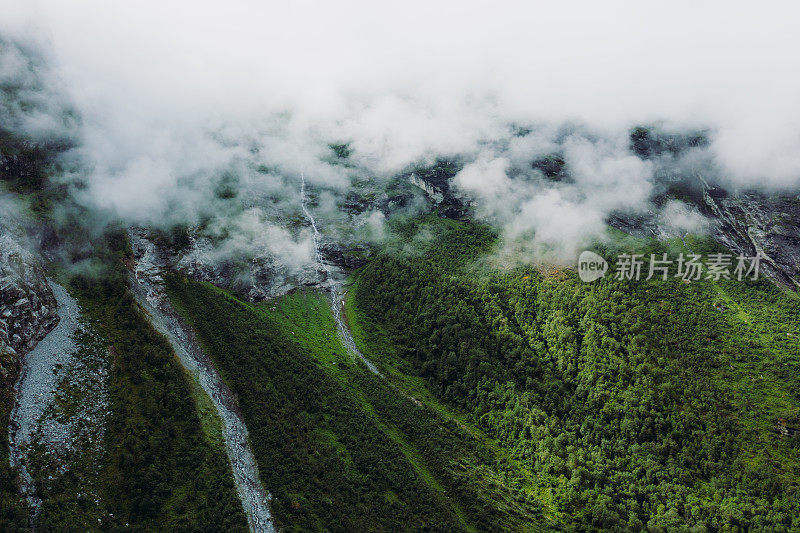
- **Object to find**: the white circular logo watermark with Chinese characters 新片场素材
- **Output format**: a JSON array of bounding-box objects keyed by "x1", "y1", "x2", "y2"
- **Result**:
[{"x1": 578, "y1": 250, "x2": 763, "y2": 283}]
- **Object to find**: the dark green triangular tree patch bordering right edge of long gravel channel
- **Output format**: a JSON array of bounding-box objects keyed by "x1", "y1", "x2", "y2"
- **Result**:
[{"x1": 168, "y1": 278, "x2": 468, "y2": 531}]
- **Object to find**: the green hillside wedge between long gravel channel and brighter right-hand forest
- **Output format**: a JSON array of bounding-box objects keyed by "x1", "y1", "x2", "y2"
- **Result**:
[{"x1": 168, "y1": 277, "x2": 544, "y2": 531}]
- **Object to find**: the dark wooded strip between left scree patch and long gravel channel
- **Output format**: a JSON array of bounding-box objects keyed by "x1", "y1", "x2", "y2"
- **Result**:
[{"x1": 45, "y1": 233, "x2": 247, "y2": 531}]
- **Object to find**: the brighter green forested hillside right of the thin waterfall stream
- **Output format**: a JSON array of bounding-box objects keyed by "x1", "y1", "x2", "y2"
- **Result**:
[{"x1": 351, "y1": 218, "x2": 800, "y2": 531}]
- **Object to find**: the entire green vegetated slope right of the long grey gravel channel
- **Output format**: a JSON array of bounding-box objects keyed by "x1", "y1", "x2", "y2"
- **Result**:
[{"x1": 168, "y1": 212, "x2": 800, "y2": 531}]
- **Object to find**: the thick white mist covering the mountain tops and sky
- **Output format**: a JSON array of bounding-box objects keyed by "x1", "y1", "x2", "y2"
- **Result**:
[{"x1": 0, "y1": 2, "x2": 800, "y2": 278}]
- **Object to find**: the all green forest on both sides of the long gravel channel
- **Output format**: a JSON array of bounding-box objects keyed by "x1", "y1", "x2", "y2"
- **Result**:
[{"x1": 6, "y1": 118, "x2": 800, "y2": 532}]
